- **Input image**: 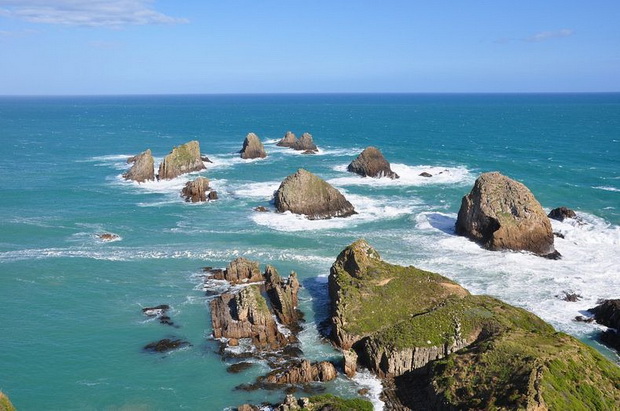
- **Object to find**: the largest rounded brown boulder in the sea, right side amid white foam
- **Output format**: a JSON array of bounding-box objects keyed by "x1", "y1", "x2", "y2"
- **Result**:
[{"x1": 456, "y1": 172, "x2": 560, "y2": 258}]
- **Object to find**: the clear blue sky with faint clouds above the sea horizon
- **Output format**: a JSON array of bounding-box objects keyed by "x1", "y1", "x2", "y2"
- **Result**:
[{"x1": 0, "y1": 0, "x2": 620, "y2": 95}]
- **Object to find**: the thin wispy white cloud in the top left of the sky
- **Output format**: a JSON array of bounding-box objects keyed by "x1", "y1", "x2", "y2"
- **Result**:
[{"x1": 0, "y1": 0, "x2": 188, "y2": 27}]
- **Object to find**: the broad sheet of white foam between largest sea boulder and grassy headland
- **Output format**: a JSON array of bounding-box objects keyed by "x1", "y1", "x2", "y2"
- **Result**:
[{"x1": 412, "y1": 212, "x2": 620, "y2": 335}]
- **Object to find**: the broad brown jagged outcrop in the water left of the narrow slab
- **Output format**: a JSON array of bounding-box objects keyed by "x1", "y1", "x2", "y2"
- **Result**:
[{"x1": 210, "y1": 285, "x2": 288, "y2": 350}]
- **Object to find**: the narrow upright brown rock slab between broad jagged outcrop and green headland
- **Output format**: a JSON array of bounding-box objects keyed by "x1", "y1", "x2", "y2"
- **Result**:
[{"x1": 265, "y1": 265, "x2": 299, "y2": 326}]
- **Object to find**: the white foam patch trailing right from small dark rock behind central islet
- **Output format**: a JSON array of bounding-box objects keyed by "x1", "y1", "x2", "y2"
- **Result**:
[{"x1": 328, "y1": 164, "x2": 475, "y2": 186}]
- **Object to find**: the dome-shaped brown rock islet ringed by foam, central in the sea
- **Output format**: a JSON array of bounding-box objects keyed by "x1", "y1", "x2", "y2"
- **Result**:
[{"x1": 274, "y1": 168, "x2": 357, "y2": 220}]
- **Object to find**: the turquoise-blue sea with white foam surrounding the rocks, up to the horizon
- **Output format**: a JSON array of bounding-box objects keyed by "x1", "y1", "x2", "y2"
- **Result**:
[{"x1": 0, "y1": 93, "x2": 620, "y2": 410}]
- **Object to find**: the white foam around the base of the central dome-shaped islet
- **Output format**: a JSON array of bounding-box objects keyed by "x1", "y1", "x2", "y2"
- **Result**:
[{"x1": 250, "y1": 194, "x2": 415, "y2": 231}]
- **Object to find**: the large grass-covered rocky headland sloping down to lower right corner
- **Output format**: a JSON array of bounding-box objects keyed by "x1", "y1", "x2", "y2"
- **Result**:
[{"x1": 329, "y1": 240, "x2": 620, "y2": 410}]
